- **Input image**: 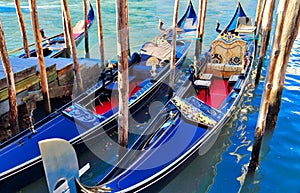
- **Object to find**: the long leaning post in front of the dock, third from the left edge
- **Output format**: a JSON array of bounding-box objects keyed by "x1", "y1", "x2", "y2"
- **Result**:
[{"x1": 29, "y1": 0, "x2": 51, "y2": 113}]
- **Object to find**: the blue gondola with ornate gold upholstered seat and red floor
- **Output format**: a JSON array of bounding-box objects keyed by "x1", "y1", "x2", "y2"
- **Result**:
[{"x1": 70, "y1": 2, "x2": 255, "y2": 193}]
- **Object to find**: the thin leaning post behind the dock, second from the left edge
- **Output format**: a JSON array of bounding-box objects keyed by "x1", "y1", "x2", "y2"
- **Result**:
[{"x1": 15, "y1": 0, "x2": 30, "y2": 58}]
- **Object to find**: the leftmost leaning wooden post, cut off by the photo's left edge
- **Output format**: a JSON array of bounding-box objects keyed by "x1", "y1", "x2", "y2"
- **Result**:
[{"x1": 0, "y1": 20, "x2": 19, "y2": 135}]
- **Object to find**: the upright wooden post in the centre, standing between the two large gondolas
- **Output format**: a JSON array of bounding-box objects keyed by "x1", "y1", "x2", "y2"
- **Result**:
[{"x1": 116, "y1": 0, "x2": 129, "y2": 159}]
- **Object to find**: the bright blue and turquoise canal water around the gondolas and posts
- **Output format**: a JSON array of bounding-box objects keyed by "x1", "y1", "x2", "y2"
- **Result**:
[{"x1": 0, "y1": 0, "x2": 300, "y2": 193}]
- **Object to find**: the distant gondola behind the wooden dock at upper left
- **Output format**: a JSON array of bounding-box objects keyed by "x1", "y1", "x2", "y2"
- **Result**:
[{"x1": 17, "y1": 2, "x2": 95, "y2": 58}]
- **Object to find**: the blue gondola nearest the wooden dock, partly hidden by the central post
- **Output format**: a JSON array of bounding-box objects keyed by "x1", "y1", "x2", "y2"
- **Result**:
[{"x1": 0, "y1": 1, "x2": 197, "y2": 192}]
